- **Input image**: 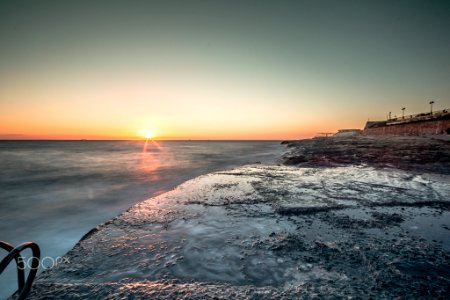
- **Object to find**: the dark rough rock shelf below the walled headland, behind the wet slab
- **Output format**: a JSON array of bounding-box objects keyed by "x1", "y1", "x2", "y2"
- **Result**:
[{"x1": 284, "y1": 135, "x2": 450, "y2": 174}]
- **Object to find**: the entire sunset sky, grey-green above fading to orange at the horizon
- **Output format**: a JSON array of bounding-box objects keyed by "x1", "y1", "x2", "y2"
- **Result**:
[{"x1": 0, "y1": 0, "x2": 450, "y2": 140}]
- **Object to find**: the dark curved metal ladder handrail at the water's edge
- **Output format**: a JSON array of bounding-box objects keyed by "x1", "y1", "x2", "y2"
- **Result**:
[{"x1": 0, "y1": 241, "x2": 41, "y2": 300}]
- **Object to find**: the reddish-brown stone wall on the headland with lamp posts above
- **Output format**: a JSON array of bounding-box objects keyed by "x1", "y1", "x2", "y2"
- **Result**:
[{"x1": 363, "y1": 109, "x2": 450, "y2": 135}]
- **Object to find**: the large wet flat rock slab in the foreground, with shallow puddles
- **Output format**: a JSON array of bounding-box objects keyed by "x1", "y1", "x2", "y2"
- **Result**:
[{"x1": 30, "y1": 166, "x2": 450, "y2": 299}]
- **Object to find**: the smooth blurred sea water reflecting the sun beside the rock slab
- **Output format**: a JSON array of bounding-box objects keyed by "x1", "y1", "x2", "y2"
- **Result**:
[{"x1": 0, "y1": 141, "x2": 284, "y2": 298}]
